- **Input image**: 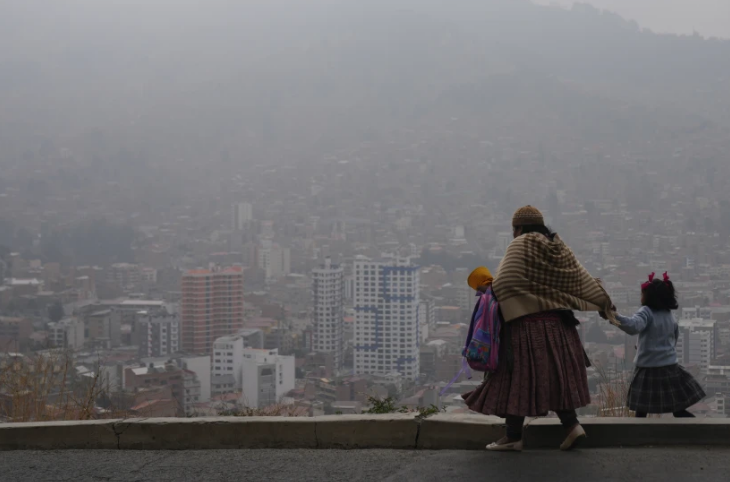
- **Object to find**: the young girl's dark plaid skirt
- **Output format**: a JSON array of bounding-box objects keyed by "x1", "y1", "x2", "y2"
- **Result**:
[{"x1": 627, "y1": 364, "x2": 705, "y2": 413}]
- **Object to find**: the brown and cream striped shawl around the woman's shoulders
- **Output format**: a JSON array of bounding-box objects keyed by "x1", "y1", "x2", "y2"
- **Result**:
[{"x1": 492, "y1": 233, "x2": 616, "y2": 323}]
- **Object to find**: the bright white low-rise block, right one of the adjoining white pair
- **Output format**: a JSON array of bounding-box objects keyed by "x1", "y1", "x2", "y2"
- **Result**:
[{"x1": 241, "y1": 348, "x2": 296, "y2": 408}]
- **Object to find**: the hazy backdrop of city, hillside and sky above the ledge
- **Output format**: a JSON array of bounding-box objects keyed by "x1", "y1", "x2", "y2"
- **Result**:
[{"x1": 0, "y1": 0, "x2": 730, "y2": 470}]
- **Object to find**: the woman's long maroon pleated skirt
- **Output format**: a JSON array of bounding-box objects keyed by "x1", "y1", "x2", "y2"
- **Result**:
[{"x1": 462, "y1": 311, "x2": 591, "y2": 418}]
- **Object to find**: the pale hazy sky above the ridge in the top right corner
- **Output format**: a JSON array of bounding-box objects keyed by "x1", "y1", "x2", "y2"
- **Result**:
[{"x1": 533, "y1": 0, "x2": 730, "y2": 38}]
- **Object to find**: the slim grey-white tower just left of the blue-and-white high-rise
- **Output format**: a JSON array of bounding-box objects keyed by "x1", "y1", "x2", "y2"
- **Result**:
[{"x1": 312, "y1": 258, "x2": 345, "y2": 370}]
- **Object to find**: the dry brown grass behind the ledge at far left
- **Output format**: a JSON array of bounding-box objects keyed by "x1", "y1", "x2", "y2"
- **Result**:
[{"x1": 0, "y1": 350, "x2": 121, "y2": 422}]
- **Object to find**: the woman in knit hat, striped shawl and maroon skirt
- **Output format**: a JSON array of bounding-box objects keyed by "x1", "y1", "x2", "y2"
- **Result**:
[{"x1": 464, "y1": 206, "x2": 612, "y2": 451}]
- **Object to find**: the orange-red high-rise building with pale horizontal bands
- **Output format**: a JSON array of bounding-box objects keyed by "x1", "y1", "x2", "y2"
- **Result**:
[{"x1": 181, "y1": 266, "x2": 243, "y2": 354}]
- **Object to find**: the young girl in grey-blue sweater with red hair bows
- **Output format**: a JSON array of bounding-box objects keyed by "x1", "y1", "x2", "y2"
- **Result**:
[{"x1": 616, "y1": 273, "x2": 705, "y2": 418}]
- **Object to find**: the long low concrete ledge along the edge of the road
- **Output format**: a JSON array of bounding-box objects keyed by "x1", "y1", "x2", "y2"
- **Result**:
[{"x1": 0, "y1": 414, "x2": 730, "y2": 450}]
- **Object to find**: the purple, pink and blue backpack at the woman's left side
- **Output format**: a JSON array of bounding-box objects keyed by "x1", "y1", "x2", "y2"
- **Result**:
[{"x1": 462, "y1": 287, "x2": 502, "y2": 373}]
